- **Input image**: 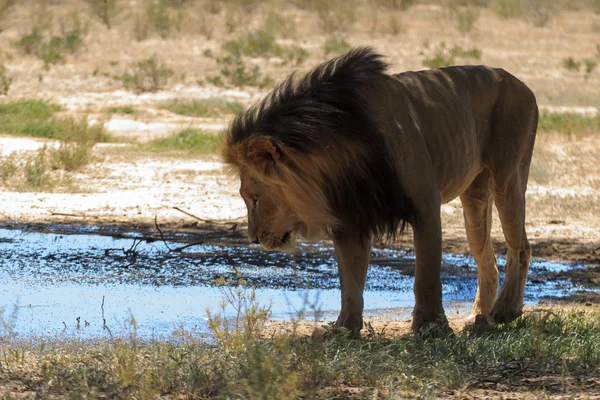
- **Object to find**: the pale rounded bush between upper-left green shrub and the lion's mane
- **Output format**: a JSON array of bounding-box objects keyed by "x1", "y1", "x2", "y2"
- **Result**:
[{"x1": 121, "y1": 55, "x2": 174, "y2": 93}]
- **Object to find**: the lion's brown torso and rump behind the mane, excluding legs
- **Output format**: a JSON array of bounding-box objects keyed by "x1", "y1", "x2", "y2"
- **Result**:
[{"x1": 369, "y1": 66, "x2": 537, "y2": 202}]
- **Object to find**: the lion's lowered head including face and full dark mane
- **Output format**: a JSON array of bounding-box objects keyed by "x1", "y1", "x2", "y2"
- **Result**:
[{"x1": 222, "y1": 48, "x2": 412, "y2": 250}]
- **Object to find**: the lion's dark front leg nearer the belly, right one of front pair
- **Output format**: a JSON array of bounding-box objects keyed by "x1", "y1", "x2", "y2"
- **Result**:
[{"x1": 412, "y1": 205, "x2": 448, "y2": 332}]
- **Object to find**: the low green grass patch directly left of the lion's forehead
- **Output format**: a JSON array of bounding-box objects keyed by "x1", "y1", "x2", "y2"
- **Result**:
[{"x1": 144, "y1": 129, "x2": 219, "y2": 154}]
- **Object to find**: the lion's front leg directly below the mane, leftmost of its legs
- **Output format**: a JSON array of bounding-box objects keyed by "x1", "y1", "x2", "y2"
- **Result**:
[{"x1": 333, "y1": 232, "x2": 371, "y2": 335}]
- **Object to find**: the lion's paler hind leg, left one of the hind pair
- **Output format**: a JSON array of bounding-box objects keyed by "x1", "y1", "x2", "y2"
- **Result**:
[{"x1": 460, "y1": 168, "x2": 498, "y2": 325}]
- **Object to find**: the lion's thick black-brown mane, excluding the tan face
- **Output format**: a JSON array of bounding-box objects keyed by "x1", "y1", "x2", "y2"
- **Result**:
[{"x1": 225, "y1": 47, "x2": 415, "y2": 238}]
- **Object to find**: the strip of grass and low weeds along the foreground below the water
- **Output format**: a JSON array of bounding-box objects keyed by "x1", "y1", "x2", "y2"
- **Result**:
[{"x1": 0, "y1": 292, "x2": 600, "y2": 399}]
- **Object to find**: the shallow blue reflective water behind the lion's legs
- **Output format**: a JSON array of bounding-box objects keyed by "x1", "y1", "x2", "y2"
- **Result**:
[{"x1": 0, "y1": 228, "x2": 592, "y2": 338}]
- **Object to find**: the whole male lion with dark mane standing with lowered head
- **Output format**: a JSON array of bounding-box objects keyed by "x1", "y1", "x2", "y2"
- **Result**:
[{"x1": 223, "y1": 48, "x2": 538, "y2": 334}]
